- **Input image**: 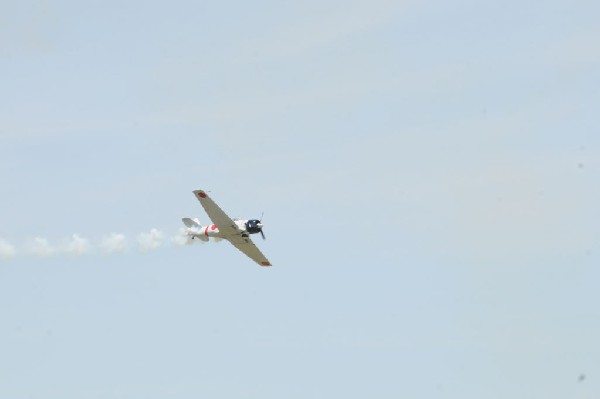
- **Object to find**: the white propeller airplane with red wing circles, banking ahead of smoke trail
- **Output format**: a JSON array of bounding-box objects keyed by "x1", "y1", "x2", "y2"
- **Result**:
[{"x1": 181, "y1": 190, "x2": 271, "y2": 266}]
